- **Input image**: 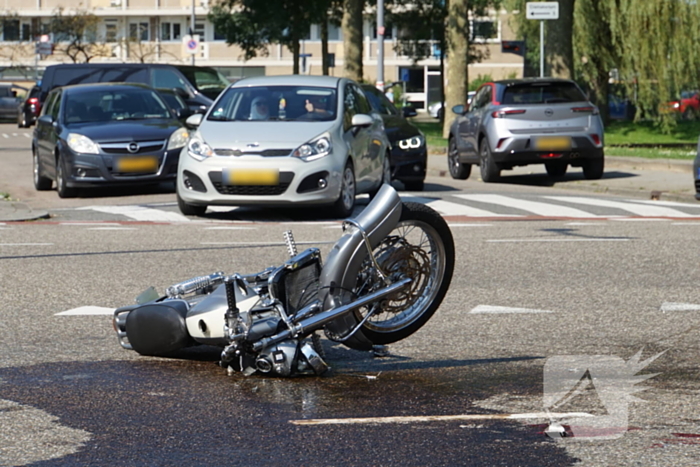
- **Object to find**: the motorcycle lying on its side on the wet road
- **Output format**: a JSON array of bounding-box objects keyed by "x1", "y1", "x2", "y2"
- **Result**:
[{"x1": 113, "y1": 184, "x2": 454, "y2": 376}]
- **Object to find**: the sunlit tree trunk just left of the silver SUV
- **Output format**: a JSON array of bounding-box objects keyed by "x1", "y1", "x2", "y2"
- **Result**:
[{"x1": 442, "y1": 0, "x2": 469, "y2": 138}]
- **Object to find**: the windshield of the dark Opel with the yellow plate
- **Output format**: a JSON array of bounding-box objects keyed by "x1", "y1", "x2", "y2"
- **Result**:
[{"x1": 63, "y1": 88, "x2": 172, "y2": 124}]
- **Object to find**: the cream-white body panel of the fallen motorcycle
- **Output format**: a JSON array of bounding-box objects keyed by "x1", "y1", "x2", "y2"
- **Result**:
[{"x1": 186, "y1": 284, "x2": 260, "y2": 345}]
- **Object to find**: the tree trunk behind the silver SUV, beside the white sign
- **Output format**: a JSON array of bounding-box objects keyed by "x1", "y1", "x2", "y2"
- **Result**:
[{"x1": 544, "y1": 0, "x2": 575, "y2": 79}]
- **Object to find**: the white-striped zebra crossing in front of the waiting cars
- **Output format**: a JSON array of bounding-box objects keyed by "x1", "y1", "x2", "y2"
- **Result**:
[{"x1": 67, "y1": 193, "x2": 700, "y2": 223}]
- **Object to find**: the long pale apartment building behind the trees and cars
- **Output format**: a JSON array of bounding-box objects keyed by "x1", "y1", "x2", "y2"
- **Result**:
[{"x1": 0, "y1": 0, "x2": 523, "y2": 108}]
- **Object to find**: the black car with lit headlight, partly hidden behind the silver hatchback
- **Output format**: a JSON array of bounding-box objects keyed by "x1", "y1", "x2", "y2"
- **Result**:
[{"x1": 362, "y1": 84, "x2": 428, "y2": 191}]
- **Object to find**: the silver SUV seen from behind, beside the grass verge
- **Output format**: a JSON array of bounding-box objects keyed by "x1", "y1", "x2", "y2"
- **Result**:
[{"x1": 448, "y1": 78, "x2": 604, "y2": 183}]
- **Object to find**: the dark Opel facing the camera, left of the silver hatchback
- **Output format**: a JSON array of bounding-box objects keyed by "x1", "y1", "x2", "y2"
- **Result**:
[{"x1": 32, "y1": 83, "x2": 189, "y2": 198}]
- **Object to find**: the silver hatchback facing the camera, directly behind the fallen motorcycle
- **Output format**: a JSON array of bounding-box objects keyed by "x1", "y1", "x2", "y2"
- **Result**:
[{"x1": 177, "y1": 75, "x2": 391, "y2": 217}]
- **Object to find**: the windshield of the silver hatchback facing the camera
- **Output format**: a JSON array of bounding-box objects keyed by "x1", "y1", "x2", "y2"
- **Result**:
[{"x1": 207, "y1": 86, "x2": 337, "y2": 122}]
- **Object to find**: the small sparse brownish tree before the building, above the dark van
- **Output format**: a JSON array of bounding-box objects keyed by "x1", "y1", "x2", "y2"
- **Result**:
[{"x1": 49, "y1": 7, "x2": 112, "y2": 63}]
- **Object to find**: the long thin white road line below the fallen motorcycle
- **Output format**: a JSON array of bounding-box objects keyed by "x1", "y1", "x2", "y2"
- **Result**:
[{"x1": 289, "y1": 412, "x2": 593, "y2": 425}]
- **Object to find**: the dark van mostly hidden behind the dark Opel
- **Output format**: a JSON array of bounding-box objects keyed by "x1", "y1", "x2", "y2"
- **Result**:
[{"x1": 39, "y1": 63, "x2": 230, "y2": 117}]
